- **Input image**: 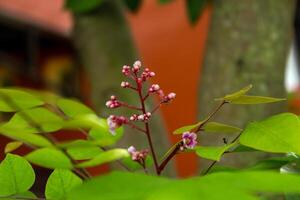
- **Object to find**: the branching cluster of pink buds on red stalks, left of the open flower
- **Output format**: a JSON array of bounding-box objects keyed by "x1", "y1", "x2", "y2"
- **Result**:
[{"x1": 106, "y1": 61, "x2": 176, "y2": 161}]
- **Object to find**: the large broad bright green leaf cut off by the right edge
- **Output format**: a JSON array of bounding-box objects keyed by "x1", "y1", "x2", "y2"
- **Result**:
[{"x1": 240, "y1": 113, "x2": 300, "y2": 155}]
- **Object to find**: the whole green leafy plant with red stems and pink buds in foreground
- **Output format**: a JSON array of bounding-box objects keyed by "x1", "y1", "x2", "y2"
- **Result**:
[{"x1": 0, "y1": 61, "x2": 300, "y2": 200}]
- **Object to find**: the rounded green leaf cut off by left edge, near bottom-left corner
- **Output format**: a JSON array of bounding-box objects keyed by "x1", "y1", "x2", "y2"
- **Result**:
[{"x1": 0, "y1": 153, "x2": 35, "y2": 197}]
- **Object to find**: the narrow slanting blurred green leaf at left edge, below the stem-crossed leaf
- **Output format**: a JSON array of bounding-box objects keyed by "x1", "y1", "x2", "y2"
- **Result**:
[{"x1": 0, "y1": 123, "x2": 52, "y2": 147}]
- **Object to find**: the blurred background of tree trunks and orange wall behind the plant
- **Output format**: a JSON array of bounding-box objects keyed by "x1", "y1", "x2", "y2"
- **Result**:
[{"x1": 0, "y1": 0, "x2": 300, "y2": 183}]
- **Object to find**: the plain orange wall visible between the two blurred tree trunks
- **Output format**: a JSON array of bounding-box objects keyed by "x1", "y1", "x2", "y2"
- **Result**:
[{"x1": 128, "y1": 0, "x2": 211, "y2": 177}]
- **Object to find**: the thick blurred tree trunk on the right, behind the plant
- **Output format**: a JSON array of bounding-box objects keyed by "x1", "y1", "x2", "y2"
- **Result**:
[{"x1": 199, "y1": 0, "x2": 295, "y2": 168}]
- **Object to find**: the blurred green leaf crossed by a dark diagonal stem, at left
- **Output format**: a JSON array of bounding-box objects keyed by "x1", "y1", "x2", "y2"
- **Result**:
[{"x1": 5, "y1": 107, "x2": 63, "y2": 133}]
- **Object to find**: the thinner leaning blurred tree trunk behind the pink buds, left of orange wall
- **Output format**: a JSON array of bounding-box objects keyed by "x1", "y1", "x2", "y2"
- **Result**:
[{"x1": 73, "y1": 0, "x2": 175, "y2": 174}]
